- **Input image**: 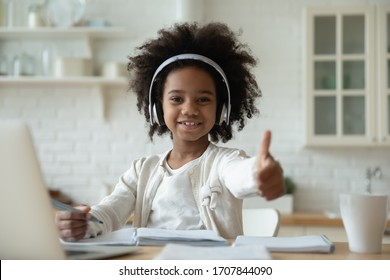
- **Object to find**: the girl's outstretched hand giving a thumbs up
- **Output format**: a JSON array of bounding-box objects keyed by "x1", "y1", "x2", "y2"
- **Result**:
[{"x1": 255, "y1": 130, "x2": 285, "y2": 200}]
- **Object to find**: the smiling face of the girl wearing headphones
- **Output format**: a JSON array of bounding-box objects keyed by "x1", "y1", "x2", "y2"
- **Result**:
[{"x1": 162, "y1": 66, "x2": 217, "y2": 147}]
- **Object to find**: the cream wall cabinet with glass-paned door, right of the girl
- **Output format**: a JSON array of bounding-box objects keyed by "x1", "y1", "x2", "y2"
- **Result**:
[{"x1": 305, "y1": 6, "x2": 390, "y2": 146}]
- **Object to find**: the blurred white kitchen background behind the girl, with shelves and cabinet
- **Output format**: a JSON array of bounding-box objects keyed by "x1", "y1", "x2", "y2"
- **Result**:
[{"x1": 0, "y1": 0, "x2": 390, "y2": 215}]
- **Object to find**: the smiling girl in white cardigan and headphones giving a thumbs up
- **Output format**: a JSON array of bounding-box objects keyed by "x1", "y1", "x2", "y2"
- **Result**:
[{"x1": 56, "y1": 23, "x2": 284, "y2": 241}]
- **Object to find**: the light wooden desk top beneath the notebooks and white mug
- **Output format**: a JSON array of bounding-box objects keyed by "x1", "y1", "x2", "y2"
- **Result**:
[{"x1": 113, "y1": 242, "x2": 390, "y2": 260}]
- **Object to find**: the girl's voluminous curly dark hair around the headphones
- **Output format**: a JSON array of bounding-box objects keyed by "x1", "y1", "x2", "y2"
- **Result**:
[{"x1": 127, "y1": 22, "x2": 261, "y2": 143}]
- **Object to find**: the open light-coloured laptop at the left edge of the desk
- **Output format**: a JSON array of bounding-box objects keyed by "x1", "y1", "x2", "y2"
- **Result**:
[{"x1": 0, "y1": 120, "x2": 138, "y2": 260}]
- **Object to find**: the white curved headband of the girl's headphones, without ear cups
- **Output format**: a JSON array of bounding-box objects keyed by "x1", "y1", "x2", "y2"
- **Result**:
[{"x1": 149, "y1": 53, "x2": 230, "y2": 125}]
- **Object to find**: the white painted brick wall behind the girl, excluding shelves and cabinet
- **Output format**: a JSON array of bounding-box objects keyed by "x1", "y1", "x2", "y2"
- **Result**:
[{"x1": 0, "y1": 0, "x2": 390, "y2": 212}]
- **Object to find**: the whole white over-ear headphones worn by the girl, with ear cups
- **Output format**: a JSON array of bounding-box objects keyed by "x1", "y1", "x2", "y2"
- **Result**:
[{"x1": 149, "y1": 53, "x2": 231, "y2": 126}]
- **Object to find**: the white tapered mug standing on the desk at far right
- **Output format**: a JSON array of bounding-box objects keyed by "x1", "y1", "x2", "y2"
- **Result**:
[{"x1": 340, "y1": 194, "x2": 388, "y2": 253}]
